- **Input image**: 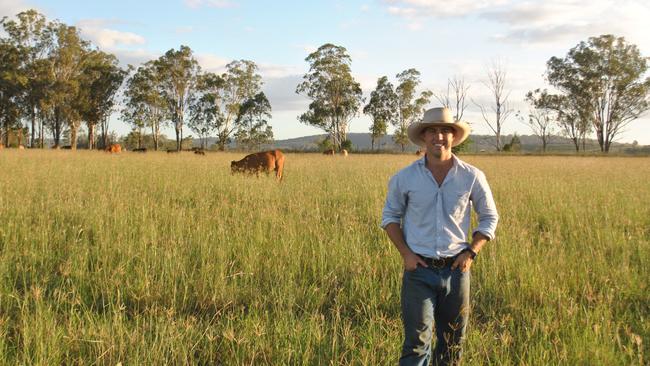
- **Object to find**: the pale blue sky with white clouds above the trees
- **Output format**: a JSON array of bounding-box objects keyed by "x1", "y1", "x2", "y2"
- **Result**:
[{"x1": 0, "y1": 0, "x2": 650, "y2": 144}]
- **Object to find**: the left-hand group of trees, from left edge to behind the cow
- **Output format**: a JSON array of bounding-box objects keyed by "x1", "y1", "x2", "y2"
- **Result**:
[{"x1": 0, "y1": 10, "x2": 273, "y2": 150}]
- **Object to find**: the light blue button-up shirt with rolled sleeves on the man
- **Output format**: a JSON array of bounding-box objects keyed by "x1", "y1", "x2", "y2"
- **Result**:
[{"x1": 381, "y1": 155, "x2": 499, "y2": 258}]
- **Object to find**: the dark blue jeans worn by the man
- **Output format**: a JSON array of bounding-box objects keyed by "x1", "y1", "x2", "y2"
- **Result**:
[{"x1": 399, "y1": 266, "x2": 470, "y2": 366}]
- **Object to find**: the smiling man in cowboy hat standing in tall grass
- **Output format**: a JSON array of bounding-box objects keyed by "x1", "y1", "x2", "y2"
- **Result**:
[{"x1": 381, "y1": 108, "x2": 499, "y2": 365}]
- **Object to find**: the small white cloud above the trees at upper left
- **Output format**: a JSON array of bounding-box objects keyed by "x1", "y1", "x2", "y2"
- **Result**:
[{"x1": 77, "y1": 19, "x2": 145, "y2": 50}]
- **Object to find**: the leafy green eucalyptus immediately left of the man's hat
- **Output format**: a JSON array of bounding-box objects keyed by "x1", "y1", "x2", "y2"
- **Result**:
[{"x1": 393, "y1": 69, "x2": 433, "y2": 151}]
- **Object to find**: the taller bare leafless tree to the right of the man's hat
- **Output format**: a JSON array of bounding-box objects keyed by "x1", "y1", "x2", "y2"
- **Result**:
[{"x1": 474, "y1": 62, "x2": 514, "y2": 151}]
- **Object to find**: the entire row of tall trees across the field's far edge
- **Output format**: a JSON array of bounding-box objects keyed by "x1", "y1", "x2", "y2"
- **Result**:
[{"x1": 0, "y1": 10, "x2": 650, "y2": 152}]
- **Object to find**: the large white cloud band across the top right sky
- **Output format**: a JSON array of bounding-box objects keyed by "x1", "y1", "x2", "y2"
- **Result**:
[{"x1": 383, "y1": 0, "x2": 650, "y2": 48}]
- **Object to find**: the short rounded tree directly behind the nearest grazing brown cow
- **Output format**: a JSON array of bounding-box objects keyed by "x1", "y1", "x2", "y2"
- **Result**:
[{"x1": 235, "y1": 92, "x2": 273, "y2": 150}]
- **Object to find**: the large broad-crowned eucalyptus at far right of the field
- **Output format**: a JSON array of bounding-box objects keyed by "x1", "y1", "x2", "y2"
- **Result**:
[{"x1": 547, "y1": 34, "x2": 650, "y2": 152}]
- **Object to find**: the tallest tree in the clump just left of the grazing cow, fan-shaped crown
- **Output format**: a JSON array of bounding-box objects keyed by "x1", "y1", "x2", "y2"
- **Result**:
[{"x1": 154, "y1": 46, "x2": 201, "y2": 151}]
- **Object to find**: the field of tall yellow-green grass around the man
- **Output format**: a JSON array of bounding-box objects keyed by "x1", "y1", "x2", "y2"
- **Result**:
[{"x1": 0, "y1": 150, "x2": 650, "y2": 365}]
